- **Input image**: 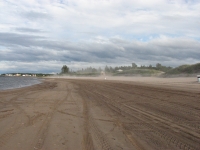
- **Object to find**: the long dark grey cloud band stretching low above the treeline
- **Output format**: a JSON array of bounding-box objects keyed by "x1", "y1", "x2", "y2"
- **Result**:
[{"x1": 0, "y1": 33, "x2": 200, "y2": 68}]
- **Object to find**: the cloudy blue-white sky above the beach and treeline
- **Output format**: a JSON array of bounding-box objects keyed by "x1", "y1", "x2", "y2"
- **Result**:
[{"x1": 0, "y1": 0, "x2": 200, "y2": 74}]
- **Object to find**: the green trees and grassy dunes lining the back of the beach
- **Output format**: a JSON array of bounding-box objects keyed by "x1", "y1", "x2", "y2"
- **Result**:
[{"x1": 60, "y1": 63, "x2": 200, "y2": 76}]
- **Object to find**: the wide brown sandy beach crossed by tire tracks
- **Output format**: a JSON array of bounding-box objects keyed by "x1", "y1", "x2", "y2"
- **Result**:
[{"x1": 0, "y1": 77, "x2": 200, "y2": 150}]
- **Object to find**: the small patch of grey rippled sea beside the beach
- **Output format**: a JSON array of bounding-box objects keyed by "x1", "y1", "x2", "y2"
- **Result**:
[{"x1": 0, "y1": 76, "x2": 42, "y2": 90}]
